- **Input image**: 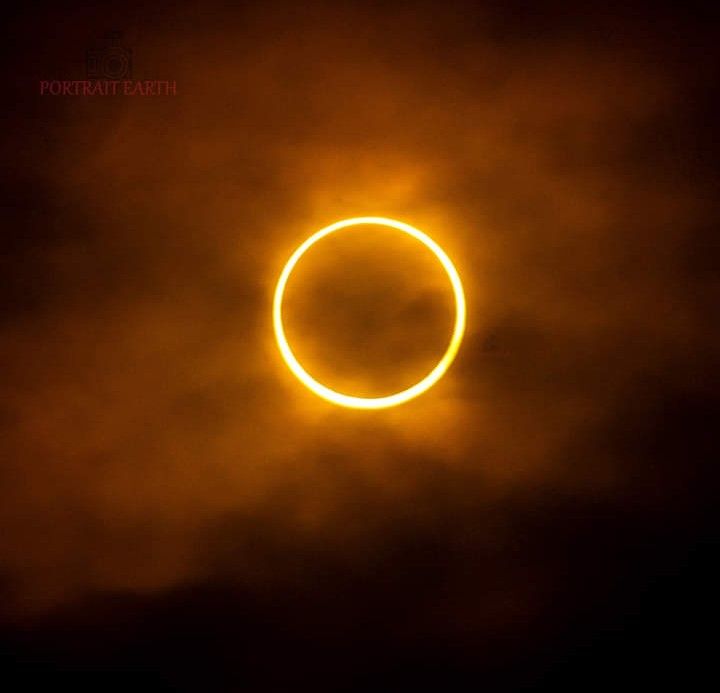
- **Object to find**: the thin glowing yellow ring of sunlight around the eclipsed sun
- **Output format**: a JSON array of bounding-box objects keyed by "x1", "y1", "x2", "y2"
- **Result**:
[{"x1": 273, "y1": 217, "x2": 466, "y2": 409}]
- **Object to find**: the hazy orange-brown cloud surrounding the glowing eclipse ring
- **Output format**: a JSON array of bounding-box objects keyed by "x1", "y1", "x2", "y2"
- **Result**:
[{"x1": 0, "y1": 3, "x2": 718, "y2": 684}]
